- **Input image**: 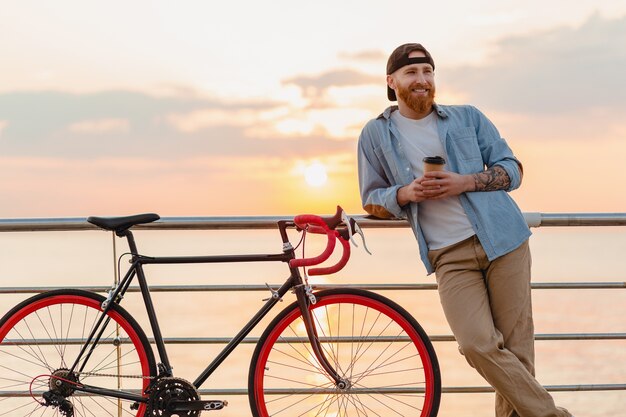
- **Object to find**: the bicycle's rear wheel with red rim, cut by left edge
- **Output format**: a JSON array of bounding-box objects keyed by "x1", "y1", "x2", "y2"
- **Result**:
[{"x1": 0, "y1": 290, "x2": 156, "y2": 417}]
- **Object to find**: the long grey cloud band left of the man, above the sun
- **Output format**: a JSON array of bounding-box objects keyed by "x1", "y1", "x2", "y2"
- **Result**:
[{"x1": 0, "y1": 91, "x2": 352, "y2": 159}]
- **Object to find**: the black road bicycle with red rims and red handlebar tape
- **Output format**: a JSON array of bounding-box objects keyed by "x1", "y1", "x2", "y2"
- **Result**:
[{"x1": 0, "y1": 207, "x2": 441, "y2": 417}]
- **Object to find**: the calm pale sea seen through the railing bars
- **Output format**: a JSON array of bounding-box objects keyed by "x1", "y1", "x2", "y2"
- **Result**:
[{"x1": 0, "y1": 227, "x2": 626, "y2": 417}]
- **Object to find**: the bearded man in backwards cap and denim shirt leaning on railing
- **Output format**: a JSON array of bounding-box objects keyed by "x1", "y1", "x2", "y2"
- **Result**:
[{"x1": 358, "y1": 43, "x2": 571, "y2": 417}]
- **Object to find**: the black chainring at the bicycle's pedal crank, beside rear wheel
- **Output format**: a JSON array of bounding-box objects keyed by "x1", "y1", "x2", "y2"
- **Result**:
[{"x1": 145, "y1": 377, "x2": 201, "y2": 417}]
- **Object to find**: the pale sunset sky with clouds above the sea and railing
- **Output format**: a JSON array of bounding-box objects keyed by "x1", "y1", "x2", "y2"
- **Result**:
[{"x1": 0, "y1": 0, "x2": 626, "y2": 218}]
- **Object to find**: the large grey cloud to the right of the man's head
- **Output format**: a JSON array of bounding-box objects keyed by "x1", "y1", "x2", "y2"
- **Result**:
[{"x1": 440, "y1": 15, "x2": 626, "y2": 114}]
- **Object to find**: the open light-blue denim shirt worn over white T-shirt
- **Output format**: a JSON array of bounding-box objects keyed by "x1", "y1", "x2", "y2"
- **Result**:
[{"x1": 358, "y1": 105, "x2": 531, "y2": 274}]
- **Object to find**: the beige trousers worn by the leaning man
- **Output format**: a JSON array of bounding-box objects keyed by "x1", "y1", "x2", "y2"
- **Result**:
[{"x1": 428, "y1": 236, "x2": 571, "y2": 417}]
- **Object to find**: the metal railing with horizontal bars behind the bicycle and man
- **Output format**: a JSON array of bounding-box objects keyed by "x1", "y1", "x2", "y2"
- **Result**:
[{"x1": 0, "y1": 212, "x2": 626, "y2": 397}]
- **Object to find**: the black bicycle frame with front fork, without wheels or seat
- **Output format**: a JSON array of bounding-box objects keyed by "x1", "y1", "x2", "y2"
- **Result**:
[{"x1": 69, "y1": 221, "x2": 343, "y2": 402}]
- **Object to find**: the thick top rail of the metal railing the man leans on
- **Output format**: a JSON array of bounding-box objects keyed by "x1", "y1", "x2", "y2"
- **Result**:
[{"x1": 0, "y1": 212, "x2": 626, "y2": 232}]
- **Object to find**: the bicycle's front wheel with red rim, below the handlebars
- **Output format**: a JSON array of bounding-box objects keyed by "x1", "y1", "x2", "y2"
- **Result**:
[{"x1": 248, "y1": 289, "x2": 441, "y2": 417}]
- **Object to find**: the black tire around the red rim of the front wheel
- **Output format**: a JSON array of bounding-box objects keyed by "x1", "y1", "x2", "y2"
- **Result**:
[{"x1": 248, "y1": 288, "x2": 441, "y2": 417}]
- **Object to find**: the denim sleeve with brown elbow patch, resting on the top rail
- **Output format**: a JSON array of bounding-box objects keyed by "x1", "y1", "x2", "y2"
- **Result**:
[{"x1": 358, "y1": 122, "x2": 404, "y2": 219}]
